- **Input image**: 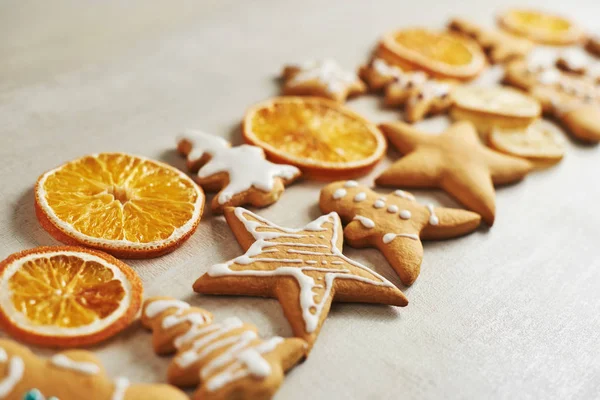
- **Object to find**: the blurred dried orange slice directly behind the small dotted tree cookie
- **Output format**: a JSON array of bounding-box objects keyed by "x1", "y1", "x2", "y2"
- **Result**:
[{"x1": 377, "y1": 28, "x2": 486, "y2": 80}]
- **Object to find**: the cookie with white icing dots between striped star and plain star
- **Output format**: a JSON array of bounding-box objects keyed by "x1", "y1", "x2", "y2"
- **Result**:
[{"x1": 319, "y1": 181, "x2": 481, "y2": 285}]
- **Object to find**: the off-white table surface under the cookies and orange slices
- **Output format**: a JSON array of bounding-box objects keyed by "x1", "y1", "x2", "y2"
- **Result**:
[{"x1": 0, "y1": 0, "x2": 600, "y2": 400}]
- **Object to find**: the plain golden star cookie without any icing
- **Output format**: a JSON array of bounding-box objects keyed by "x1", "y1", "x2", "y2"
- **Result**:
[{"x1": 375, "y1": 121, "x2": 533, "y2": 226}]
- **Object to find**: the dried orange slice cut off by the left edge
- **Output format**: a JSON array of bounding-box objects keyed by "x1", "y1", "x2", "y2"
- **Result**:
[{"x1": 0, "y1": 247, "x2": 143, "y2": 347}]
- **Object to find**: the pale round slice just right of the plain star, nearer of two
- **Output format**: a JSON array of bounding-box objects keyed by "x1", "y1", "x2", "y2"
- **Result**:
[{"x1": 489, "y1": 119, "x2": 565, "y2": 163}]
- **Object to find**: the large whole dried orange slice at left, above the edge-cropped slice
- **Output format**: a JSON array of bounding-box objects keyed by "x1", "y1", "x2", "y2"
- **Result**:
[{"x1": 35, "y1": 153, "x2": 204, "y2": 258}]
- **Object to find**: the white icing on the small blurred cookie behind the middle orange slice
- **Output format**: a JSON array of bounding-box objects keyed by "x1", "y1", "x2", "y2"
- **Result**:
[{"x1": 287, "y1": 59, "x2": 358, "y2": 94}]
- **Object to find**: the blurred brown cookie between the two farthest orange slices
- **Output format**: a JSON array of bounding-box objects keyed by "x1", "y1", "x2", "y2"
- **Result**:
[{"x1": 448, "y1": 18, "x2": 533, "y2": 64}]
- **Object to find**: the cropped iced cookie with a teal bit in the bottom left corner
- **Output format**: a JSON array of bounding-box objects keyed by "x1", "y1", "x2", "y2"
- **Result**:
[{"x1": 0, "y1": 339, "x2": 188, "y2": 400}]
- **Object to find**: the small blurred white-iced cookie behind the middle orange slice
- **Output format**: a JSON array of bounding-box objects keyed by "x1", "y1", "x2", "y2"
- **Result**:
[{"x1": 282, "y1": 60, "x2": 367, "y2": 103}]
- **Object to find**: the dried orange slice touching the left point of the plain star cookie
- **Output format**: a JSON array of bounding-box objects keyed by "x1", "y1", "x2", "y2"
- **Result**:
[{"x1": 243, "y1": 96, "x2": 387, "y2": 179}]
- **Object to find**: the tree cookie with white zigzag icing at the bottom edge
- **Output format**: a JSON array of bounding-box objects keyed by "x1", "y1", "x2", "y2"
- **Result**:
[{"x1": 142, "y1": 297, "x2": 307, "y2": 400}]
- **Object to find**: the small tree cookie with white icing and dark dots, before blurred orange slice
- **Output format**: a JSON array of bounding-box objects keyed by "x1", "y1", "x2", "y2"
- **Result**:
[{"x1": 360, "y1": 58, "x2": 455, "y2": 122}]
